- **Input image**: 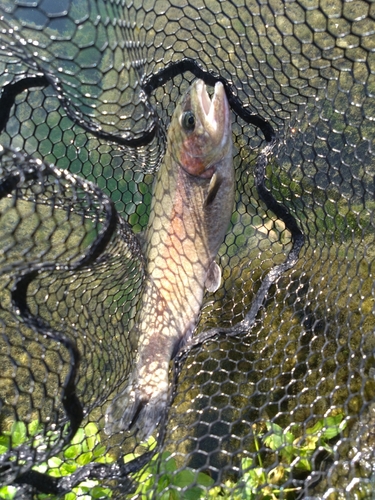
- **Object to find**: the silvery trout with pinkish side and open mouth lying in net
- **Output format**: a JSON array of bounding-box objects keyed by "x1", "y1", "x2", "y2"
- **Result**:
[{"x1": 105, "y1": 79, "x2": 234, "y2": 440}]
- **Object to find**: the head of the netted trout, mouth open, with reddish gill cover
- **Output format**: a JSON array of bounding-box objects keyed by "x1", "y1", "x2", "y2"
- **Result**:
[{"x1": 168, "y1": 80, "x2": 232, "y2": 179}]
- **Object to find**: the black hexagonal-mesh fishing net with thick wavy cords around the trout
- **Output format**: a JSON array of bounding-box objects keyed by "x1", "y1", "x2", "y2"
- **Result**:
[{"x1": 0, "y1": 0, "x2": 375, "y2": 500}]
